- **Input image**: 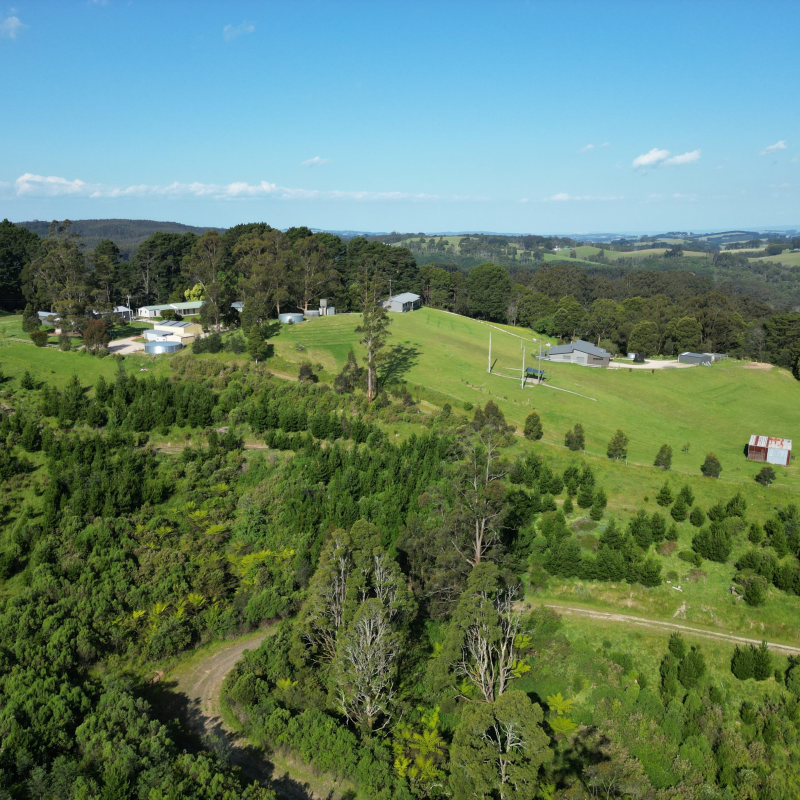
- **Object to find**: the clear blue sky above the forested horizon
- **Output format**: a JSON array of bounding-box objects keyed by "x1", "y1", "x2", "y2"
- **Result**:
[{"x1": 0, "y1": 0, "x2": 800, "y2": 233}]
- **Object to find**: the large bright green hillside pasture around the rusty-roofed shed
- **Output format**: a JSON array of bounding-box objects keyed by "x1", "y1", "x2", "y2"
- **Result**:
[{"x1": 273, "y1": 308, "x2": 800, "y2": 508}]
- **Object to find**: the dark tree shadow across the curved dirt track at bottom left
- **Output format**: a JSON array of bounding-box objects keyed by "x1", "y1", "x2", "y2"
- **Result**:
[{"x1": 146, "y1": 681, "x2": 335, "y2": 800}]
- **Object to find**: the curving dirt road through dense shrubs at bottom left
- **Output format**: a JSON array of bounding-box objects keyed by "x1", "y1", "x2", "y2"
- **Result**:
[{"x1": 161, "y1": 630, "x2": 349, "y2": 800}]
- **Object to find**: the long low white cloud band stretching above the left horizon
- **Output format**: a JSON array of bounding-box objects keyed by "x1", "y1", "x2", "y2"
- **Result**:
[{"x1": 7, "y1": 172, "x2": 487, "y2": 202}]
